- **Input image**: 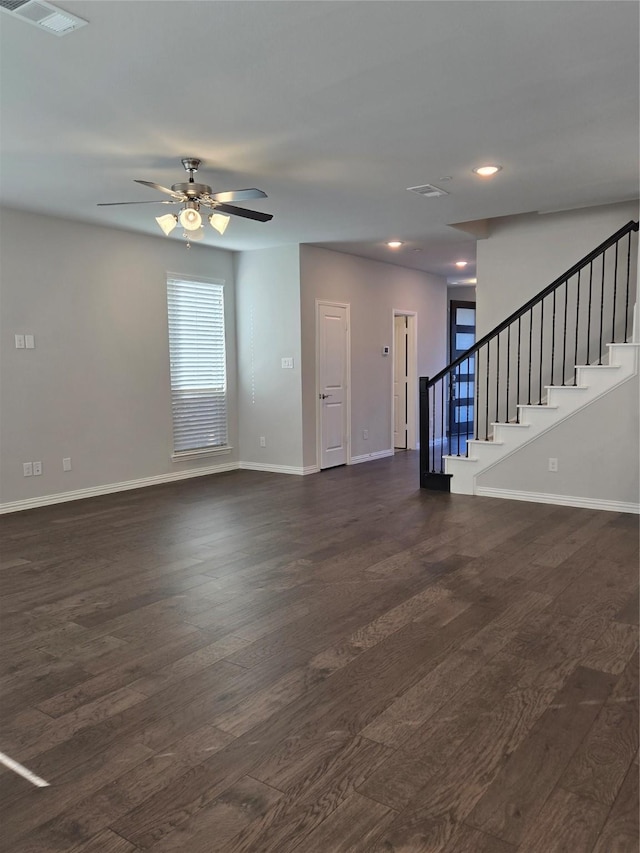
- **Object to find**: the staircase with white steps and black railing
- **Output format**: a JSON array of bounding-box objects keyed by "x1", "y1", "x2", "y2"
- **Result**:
[{"x1": 420, "y1": 221, "x2": 640, "y2": 494}]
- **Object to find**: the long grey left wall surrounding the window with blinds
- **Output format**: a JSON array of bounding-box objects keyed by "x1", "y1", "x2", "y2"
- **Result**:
[{"x1": 0, "y1": 209, "x2": 237, "y2": 503}]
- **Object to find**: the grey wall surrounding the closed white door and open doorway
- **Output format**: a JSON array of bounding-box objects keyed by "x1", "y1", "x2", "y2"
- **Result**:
[{"x1": 300, "y1": 246, "x2": 447, "y2": 465}]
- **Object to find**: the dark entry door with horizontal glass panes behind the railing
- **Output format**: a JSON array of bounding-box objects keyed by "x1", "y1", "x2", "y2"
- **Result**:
[{"x1": 447, "y1": 299, "x2": 476, "y2": 455}]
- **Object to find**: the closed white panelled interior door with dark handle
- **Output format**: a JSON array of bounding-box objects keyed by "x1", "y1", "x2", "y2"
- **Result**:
[{"x1": 317, "y1": 302, "x2": 348, "y2": 468}]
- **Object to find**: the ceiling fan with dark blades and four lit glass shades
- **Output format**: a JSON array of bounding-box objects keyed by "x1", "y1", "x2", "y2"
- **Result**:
[{"x1": 98, "y1": 157, "x2": 273, "y2": 247}]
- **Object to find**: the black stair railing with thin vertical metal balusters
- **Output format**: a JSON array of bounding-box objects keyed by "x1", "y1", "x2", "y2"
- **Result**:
[{"x1": 420, "y1": 221, "x2": 638, "y2": 491}]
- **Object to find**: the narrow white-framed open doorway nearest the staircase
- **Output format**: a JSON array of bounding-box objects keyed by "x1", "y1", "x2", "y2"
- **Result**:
[{"x1": 392, "y1": 310, "x2": 418, "y2": 450}]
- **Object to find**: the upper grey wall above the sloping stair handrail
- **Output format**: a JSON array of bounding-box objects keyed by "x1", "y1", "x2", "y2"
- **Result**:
[{"x1": 476, "y1": 201, "x2": 638, "y2": 338}]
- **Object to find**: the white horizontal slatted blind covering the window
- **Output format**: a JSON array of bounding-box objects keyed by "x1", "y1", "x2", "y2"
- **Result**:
[{"x1": 167, "y1": 277, "x2": 227, "y2": 454}]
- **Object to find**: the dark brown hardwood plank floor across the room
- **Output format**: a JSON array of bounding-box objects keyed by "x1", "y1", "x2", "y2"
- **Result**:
[{"x1": 0, "y1": 453, "x2": 639, "y2": 853}]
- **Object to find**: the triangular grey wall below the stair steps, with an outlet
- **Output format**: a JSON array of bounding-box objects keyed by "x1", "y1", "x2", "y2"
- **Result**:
[{"x1": 476, "y1": 374, "x2": 640, "y2": 505}]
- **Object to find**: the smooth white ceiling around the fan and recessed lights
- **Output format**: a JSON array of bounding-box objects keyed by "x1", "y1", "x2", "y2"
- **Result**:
[{"x1": 0, "y1": 0, "x2": 639, "y2": 278}]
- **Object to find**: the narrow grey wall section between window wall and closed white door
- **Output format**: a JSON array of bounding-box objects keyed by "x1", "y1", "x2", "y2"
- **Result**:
[{"x1": 236, "y1": 245, "x2": 303, "y2": 473}]
